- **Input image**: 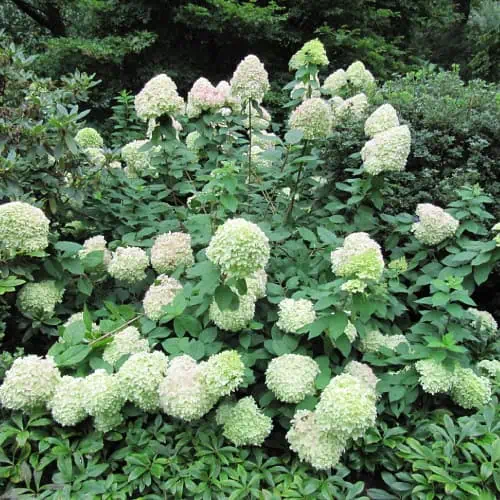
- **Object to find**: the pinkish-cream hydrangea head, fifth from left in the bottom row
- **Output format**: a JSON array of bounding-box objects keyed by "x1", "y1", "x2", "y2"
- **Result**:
[{"x1": 159, "y1": 355, "x2": 217, "y2": 422}]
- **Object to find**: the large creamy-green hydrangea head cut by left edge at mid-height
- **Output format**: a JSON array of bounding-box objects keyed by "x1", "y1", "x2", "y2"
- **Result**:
[{"x1": 0, "y1": 201, "x2": 50, "y2": 260}]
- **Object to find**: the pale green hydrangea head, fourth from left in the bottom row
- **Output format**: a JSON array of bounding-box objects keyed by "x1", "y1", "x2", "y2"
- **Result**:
[{"x1": 117, "y1": 351, "x2": 168, "y2": 412}]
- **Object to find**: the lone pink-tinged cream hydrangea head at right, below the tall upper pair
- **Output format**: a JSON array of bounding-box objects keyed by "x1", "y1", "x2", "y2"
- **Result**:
[{"x1": 411, "y1": 203, "x2": 459, "y2": 246}]
